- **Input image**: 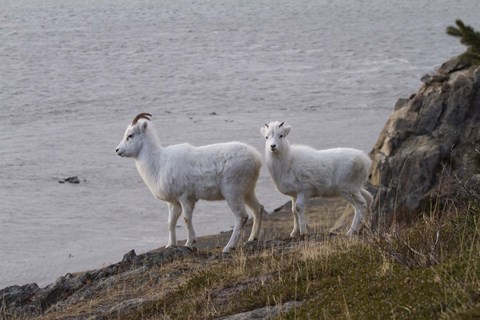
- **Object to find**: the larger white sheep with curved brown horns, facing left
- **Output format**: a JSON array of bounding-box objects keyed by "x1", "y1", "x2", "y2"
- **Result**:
[{"x1": 116, "y1": 113, "x2": 263, "y2": 253}]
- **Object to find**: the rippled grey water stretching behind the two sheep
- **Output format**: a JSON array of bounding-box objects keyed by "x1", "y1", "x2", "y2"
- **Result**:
[{"x1": 0, "y1": 0, "x2": 480, "y2": 288}]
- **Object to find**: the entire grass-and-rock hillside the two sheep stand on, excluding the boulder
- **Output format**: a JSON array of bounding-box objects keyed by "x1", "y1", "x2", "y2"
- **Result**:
[{"x1": 1, "y1": 194, "x2": 480, "y2": 319}]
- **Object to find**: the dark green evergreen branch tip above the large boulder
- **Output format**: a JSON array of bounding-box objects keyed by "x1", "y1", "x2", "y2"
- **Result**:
[{"x1": 446, "y1": 19, "x2": 480, "y2": 64}]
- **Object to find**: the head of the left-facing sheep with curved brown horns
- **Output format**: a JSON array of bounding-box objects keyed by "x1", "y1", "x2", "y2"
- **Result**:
[{"x1": 116, "y1": 113, "x2": 152, "y2": 158}]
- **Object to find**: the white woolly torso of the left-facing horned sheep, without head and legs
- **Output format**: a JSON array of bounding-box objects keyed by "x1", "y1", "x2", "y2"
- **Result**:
[{"x1": 136, "y1": 142, "x2": 261, "y2": 203}]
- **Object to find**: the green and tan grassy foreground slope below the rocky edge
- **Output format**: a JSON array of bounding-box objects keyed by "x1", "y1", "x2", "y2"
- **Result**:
[{"x1": 32, "y1": 199, "x2": 480, "y2": 319}]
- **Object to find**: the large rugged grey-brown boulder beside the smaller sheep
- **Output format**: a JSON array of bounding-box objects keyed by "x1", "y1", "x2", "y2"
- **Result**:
[{"x1": 370, "y1": 59, "x2": 480, "y2": 229}]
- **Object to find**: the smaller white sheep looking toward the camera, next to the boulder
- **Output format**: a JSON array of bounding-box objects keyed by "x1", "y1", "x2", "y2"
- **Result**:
[{"x1": 260, "y1": 121, "x2": 373, "y2": 238}]
